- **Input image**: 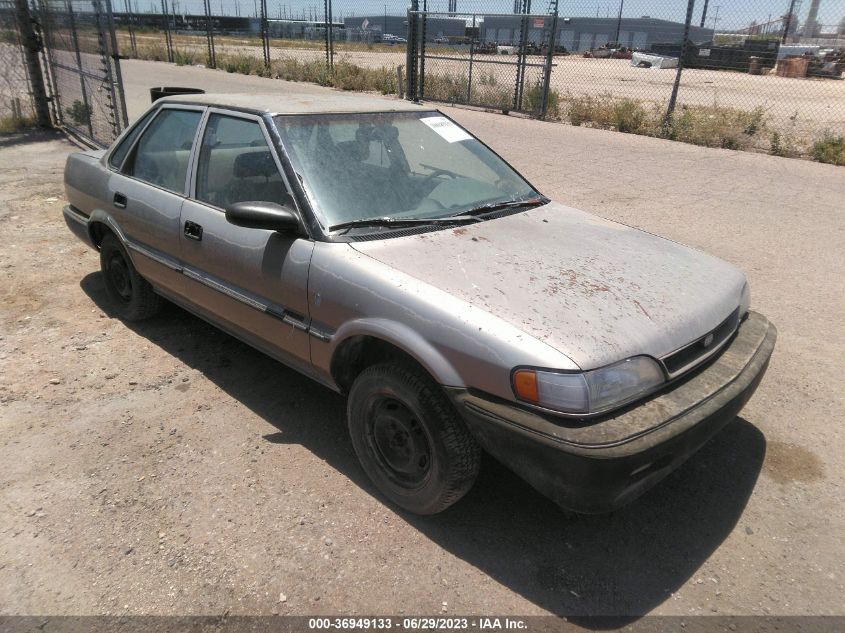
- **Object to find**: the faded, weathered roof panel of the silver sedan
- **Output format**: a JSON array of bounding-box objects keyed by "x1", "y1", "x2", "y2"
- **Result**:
[{"x1": 159, "y1": 92, "x2": 433, "y2": 114}]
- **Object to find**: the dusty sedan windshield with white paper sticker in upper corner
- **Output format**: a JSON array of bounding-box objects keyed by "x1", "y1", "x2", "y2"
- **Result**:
[{"x1": 276, "y1": 112, "x2": 539, "y2": 228}]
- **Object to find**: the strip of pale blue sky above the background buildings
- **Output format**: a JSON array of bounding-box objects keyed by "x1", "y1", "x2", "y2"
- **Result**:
[{"x1": 129, "y1": 0, "x2": 845, "y2": 30}]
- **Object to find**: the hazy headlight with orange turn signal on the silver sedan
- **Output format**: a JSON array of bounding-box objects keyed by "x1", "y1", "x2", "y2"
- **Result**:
[{"x1": 513, "y1": 356, "x2": 665, "y2": 414}]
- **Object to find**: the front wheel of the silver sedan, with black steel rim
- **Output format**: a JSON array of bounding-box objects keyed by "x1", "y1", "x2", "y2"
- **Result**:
[{"x1": 347, "y1": 362, "x2": 481, "y2": 514}]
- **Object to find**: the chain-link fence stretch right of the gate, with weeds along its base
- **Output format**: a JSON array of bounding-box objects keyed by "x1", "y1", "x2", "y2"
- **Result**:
[{"x1": 551, "y1": 0, "x2": 845, "y2": 156}]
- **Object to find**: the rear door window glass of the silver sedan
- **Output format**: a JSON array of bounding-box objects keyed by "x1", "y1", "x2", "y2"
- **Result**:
[{"x1": 125, "y1": 110, "x2": 202, "y2": 194}]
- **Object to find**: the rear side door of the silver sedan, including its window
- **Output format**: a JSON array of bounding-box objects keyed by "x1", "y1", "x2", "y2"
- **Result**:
[{"x1": 106, "y1": 105, "x2": 204, "y2": 294}]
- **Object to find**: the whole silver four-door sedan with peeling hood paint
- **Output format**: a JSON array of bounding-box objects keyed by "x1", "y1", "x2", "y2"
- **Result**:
[{"x1": 64, "y1": 93, "x2": 776, "y2": 514}]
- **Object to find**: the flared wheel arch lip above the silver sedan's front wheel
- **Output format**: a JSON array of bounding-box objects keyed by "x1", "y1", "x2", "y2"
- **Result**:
[{"x1": 330, "y1": 318, "x2": 467, "y2": 387}]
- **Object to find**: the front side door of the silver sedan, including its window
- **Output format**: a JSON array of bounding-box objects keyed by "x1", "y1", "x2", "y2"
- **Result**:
[{"x1": 180, "y1": 109, "x2": 314, "y2": 365}]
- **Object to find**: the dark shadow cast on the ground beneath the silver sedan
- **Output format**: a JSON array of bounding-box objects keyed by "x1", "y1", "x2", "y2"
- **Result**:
[{"x1": 81, "y1": 272, "x2": 766, "y2": 628}]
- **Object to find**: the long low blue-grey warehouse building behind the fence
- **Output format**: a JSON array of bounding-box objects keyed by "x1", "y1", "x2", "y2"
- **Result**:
[{"x1": 480, "y1": 15, "x2": 713, "y2": 52}]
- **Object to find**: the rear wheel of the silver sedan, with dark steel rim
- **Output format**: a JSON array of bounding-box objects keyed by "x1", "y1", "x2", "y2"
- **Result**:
[{"x1": 100, "y1": 234, "x2": 164, "y2": 321}]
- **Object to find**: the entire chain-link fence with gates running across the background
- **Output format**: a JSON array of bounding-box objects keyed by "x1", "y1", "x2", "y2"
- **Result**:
[{"x1": 0, "y1": 0, "x2": 845, "y2": 162}]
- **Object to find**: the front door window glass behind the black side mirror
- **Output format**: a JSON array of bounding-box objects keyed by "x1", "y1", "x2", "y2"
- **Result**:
[{"x1": 197, "y1": 114, "x2": 292, "y2": 209}]
